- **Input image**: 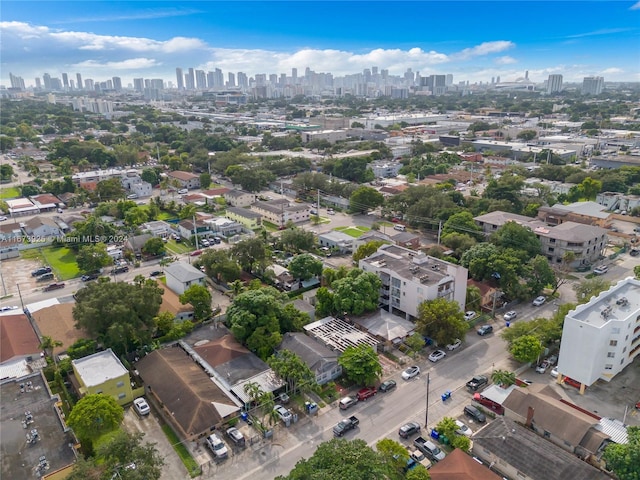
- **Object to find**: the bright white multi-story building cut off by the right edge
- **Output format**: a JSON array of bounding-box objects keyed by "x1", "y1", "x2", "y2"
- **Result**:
[{"x1": 558, "y1": 277, "x2": 640, "y2": 393}]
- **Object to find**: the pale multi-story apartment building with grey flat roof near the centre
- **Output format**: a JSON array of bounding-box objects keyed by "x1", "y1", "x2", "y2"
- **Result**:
[{"x1": 360, "y1": 245, "x2": 468, "y2": 320}]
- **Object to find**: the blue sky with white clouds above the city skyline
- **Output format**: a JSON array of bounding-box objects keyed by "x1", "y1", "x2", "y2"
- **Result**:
[{"x1": 0, "y1": 0, "x2": 640, "y2": 85}]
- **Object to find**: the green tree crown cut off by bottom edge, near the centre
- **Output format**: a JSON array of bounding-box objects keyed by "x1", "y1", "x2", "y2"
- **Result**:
[{"x1": 276, "y1": 438, "x2": 388, "y2": 480}]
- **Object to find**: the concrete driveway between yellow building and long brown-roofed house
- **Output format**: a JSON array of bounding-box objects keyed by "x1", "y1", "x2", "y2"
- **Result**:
[{"x1": 124, "y1": 408, "x2": 191, "y2": 480}]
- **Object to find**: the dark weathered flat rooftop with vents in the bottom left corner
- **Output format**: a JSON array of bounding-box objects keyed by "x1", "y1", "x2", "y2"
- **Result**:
[{"x1": 0, "y1": 373, "x2": 75, "y2": 479}]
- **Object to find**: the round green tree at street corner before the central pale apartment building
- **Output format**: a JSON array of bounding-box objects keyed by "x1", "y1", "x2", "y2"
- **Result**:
[{"x1": 416, "y1": 298, "x2": 469, "y2": 345}]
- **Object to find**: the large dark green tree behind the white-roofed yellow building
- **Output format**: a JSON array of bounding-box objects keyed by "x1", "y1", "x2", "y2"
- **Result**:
[{"x1": 73, "y1": 279, "x2": 162, "y2": 353}]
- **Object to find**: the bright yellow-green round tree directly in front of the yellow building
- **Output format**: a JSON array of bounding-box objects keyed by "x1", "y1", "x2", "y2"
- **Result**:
[{"x1": 68, "y1": 394, "x2": 124, "y2": 442}]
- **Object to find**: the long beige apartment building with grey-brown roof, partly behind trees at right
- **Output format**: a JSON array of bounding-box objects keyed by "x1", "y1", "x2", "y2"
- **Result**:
[{"x1": 474, "y1": 211, "x2": 607, "y2": 267}]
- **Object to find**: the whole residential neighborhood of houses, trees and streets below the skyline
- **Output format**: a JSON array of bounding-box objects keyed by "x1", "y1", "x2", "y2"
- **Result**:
[{"x1": 0, "y1": 57, "x2": 640, "y2": 480}]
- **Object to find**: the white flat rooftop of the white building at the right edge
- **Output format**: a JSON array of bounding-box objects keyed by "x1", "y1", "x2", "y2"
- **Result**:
[{"x1": 567, "y1": 278, "x2": 640, "y2": 328}]
